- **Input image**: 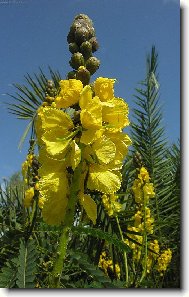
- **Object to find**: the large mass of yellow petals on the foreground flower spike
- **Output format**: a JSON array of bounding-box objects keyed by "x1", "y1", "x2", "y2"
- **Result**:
[{"x1": 35, "y1": 77, "x2": 131, "y2": 224}]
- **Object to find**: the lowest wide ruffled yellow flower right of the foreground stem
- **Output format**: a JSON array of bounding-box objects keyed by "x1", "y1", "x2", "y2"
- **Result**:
[{"x1": 87, "y1": 164, "x2": 122, "y2": 194}]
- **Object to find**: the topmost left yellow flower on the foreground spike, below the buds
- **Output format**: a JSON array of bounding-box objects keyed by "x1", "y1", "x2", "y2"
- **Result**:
[{"x1": 55, "y1": 79, "x2": 83, "y2": 108}]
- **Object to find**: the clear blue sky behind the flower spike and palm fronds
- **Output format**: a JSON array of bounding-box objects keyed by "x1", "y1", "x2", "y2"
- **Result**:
[{"x1": 0, "y1": 0, "x2": 180, "y2": 179}]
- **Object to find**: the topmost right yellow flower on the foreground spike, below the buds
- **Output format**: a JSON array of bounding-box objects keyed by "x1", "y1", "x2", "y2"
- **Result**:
[{"x1": 94, "y1": 77, "x2": 116, "y2": 101}]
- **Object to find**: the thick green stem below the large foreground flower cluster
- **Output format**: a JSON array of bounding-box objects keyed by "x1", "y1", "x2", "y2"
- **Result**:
[{"x1": 51, "y1": 162, "x2": 82, "y2": 288}]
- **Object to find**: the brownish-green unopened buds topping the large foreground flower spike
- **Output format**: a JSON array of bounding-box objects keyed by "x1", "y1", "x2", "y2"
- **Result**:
[{"x1": 67, "y1": 14, "x2": 100, "y2": 85}]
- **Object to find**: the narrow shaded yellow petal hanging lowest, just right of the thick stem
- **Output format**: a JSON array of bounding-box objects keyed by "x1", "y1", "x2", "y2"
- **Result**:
[{"x1": 79, "y1": 192, "x2": 97, "y2": 225}]
